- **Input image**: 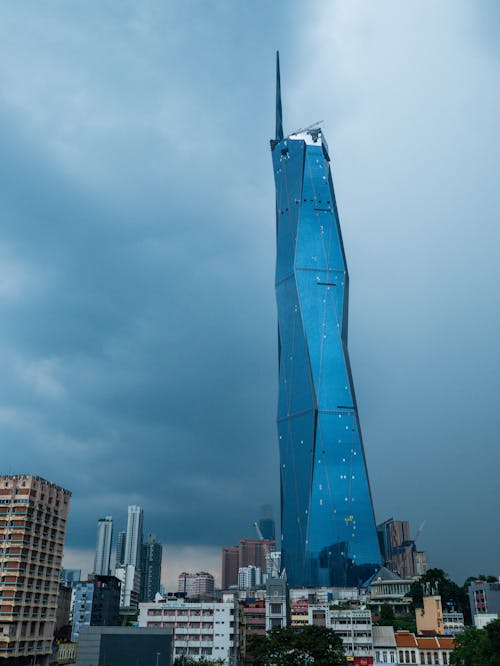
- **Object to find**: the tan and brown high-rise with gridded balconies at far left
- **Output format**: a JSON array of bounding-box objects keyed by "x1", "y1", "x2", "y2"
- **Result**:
[{"x1": 0, "y1": 474, "x2": 71, "y2": 666}]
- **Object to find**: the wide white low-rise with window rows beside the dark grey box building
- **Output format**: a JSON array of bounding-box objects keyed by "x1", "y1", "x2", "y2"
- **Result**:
[{"x1": 139, "y1": 594, "x2": 240, "y2": 666}]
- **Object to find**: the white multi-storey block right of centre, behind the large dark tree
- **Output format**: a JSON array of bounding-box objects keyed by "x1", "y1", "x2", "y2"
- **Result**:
[{"x1": 308, "y1": 605, "x2": 373, "y2": 657}]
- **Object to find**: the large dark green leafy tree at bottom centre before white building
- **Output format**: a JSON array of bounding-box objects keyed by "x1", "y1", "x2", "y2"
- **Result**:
[{"x1": 249, "y1": 625, "x2": 344, "y2": 666}]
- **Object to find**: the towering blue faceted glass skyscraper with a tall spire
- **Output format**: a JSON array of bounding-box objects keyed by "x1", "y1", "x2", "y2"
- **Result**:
[{"x1": 271, "y1": 54, "x2": 380, "y2": 587}]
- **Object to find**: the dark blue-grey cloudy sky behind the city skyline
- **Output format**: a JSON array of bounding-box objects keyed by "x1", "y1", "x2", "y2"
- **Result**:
[{"x1": 0, "y1": 0, "x2": 500, "y2": 582}]
